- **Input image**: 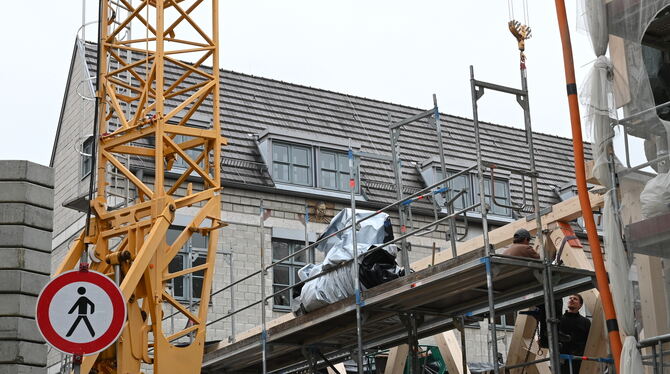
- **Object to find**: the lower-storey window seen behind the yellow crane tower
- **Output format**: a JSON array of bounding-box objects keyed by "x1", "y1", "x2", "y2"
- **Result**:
[{"x1": 166, "y1": 227, "x2": 208, "y2": 303}]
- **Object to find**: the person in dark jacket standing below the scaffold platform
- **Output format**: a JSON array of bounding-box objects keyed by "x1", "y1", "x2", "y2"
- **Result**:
[{"x1": 558, "y1": 294, "x2": 591, "y2": 374}]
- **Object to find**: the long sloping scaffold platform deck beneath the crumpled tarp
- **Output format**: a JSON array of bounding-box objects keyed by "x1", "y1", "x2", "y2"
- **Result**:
[{"x1": 202, "y1": 249, "x2": 595, "y2": 373}]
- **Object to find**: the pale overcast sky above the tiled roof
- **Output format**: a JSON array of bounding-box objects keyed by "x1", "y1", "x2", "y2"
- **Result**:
[{"x1": 0, "y1": 0, "x2": 594, "y2": 165}]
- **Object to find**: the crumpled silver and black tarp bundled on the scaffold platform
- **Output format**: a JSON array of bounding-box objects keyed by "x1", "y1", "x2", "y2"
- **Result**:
[{"x1": 293, "y1": 209, "x2": 404, "y2": 314}]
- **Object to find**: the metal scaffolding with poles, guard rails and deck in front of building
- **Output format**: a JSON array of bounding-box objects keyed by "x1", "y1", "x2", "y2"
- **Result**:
[{"x1": 203, "y1": 61, "x2": 598, "y2": 374}]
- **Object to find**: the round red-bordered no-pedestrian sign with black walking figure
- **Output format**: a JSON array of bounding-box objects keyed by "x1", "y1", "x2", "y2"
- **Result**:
[{"x1": 35, "y1": 270, "x2": 126, "y2": 355}]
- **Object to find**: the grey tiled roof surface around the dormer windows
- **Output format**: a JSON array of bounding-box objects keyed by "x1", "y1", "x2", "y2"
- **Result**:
[{"x1": 81, "y1": 44, "x2": 590, "y2": 210}]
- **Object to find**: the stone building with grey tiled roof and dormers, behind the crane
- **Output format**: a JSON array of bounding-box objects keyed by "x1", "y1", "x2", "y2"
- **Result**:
[{"x1": 49, "y1": 41, "x2": 592, "y2": 372}]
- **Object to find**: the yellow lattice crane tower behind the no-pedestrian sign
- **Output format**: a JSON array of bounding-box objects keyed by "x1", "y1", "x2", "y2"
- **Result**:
[{"x1": 56, "y1": 0, "x2": 227, "y2": 374}]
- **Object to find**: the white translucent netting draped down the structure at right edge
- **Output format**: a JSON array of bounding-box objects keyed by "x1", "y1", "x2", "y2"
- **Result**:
[{"x1": 580, "y1": 0, "x2": 670, "y2": 374}]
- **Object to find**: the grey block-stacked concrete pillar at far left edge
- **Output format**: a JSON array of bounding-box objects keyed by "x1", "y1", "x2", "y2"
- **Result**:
[{"x1": 0, "y1": 160, "x2": 54, "y2": 374}]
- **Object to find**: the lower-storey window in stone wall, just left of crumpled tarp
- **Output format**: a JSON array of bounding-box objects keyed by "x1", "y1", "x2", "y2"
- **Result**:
[{"x1": 272, "y1": 239, "x2": 307, "y2": 310}]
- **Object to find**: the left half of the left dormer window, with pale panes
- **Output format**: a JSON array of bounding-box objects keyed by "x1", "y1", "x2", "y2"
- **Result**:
[{"x1": 272, "y1": 143, "x2": 312, "y2": 186}]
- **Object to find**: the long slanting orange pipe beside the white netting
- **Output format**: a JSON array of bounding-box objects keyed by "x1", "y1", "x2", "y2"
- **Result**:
[{"x1": 555, "y1": 0, "x2": 621, "y2": 373}]
